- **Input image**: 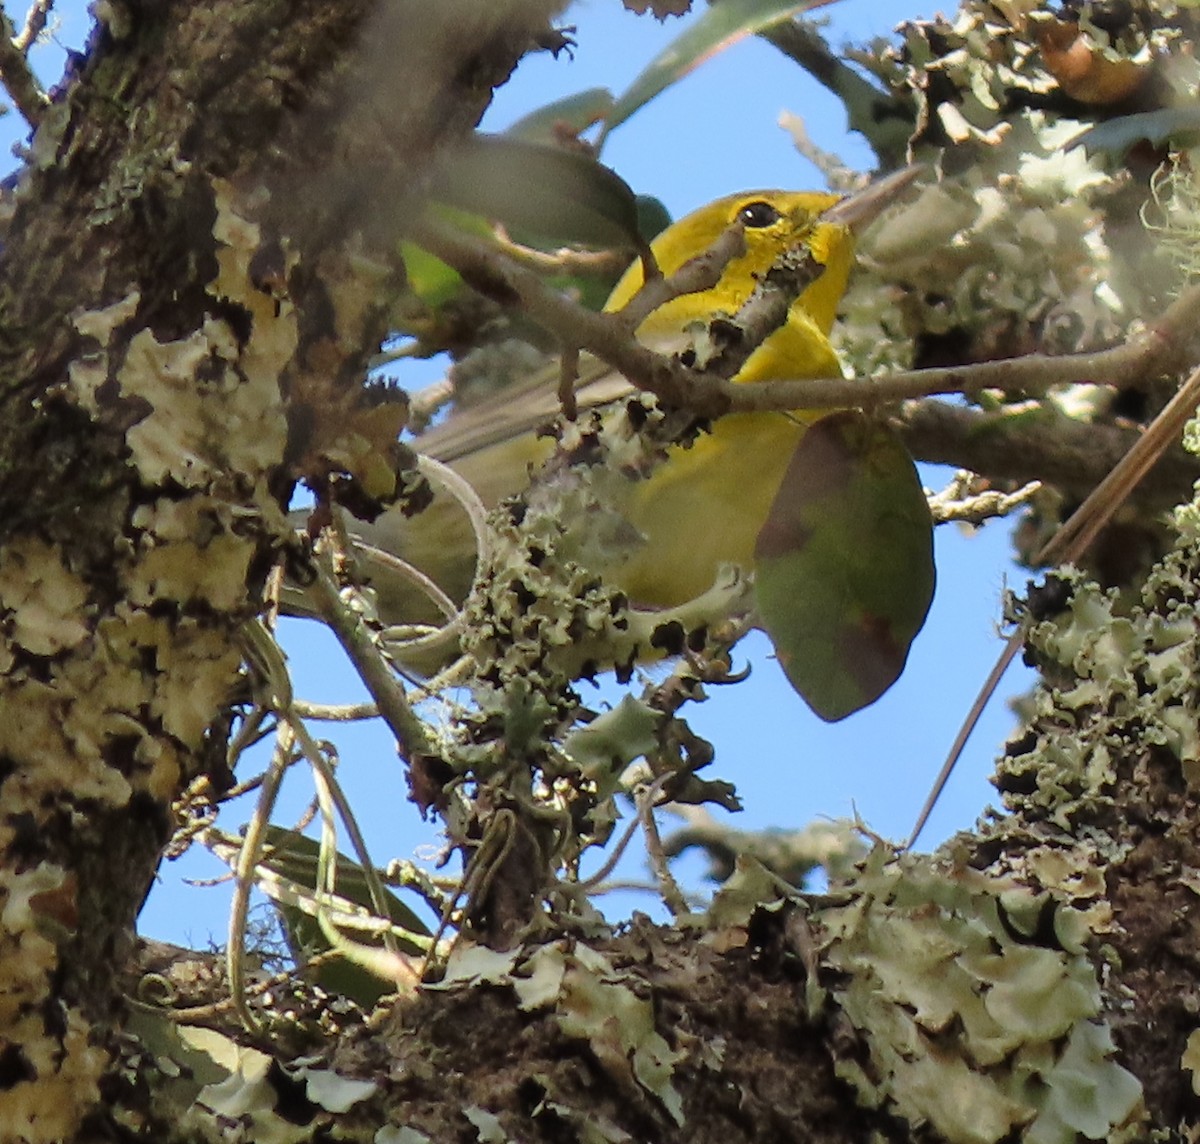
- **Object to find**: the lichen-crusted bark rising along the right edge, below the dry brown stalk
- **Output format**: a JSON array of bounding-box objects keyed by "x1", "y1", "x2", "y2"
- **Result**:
[{"x1": 977, "y1": 525, "x2": 1200, "y2": 1128}]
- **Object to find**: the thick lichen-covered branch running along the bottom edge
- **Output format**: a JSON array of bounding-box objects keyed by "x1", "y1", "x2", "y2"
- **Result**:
[{"x1": 121, "y1": 847, "x2": 1146, "y2": 1144}]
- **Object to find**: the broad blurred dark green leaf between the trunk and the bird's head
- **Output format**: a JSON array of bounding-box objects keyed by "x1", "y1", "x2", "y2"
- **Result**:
[{"x1": 430, "y1": 134, "x2": 640, "y2": 247}]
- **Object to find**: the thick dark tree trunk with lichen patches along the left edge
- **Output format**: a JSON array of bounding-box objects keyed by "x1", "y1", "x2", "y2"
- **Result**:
[{"x1": 0, "y1": 0, "x2": 556, "y2": 1140}]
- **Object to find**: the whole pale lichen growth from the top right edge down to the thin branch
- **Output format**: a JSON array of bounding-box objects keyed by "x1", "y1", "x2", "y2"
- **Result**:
[{"x1": 834, "y1": 0, "x2": 1196, "y2": 375}]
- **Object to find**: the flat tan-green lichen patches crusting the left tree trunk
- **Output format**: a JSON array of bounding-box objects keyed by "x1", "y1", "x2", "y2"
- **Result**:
[{"x1": 0, "y1": 166, "x2": 296, "y2": 1144}]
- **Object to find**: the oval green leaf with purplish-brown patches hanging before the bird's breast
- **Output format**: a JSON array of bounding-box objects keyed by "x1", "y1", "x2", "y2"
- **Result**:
[{"x1": 755, "y1": 412, "x2": 935, "y2": 723}]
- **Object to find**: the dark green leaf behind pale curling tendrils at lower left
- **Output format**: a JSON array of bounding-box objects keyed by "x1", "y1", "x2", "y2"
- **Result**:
[{"x1": 259, "y1": 826, "x2": 430, "y2": 1010}]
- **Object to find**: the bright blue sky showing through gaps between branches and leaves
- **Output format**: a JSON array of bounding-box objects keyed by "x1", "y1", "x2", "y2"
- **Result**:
[{"x1": 0, "y1": 0, "x2": 1027, "y2": 944}]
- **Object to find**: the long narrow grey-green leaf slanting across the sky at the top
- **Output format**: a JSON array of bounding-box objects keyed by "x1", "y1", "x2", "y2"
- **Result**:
[{"x1": 596, "y1": 0, "x2": 830, "y2": 149}]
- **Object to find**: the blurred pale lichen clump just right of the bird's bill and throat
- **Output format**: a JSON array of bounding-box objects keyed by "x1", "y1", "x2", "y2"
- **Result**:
[{"x1": 834, "y1": 110, "x2": 1141, "y2": 373}]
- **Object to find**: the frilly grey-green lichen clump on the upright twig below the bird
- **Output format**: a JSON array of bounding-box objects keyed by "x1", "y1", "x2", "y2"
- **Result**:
[{"x1": 422, "y1": 396, "x2": 750, "y2": 891}]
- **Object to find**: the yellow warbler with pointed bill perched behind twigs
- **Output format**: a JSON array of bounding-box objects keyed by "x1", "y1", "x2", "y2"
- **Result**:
[{"x1": 324, "y1": 176, "x2": 908, "y2": 623}]
